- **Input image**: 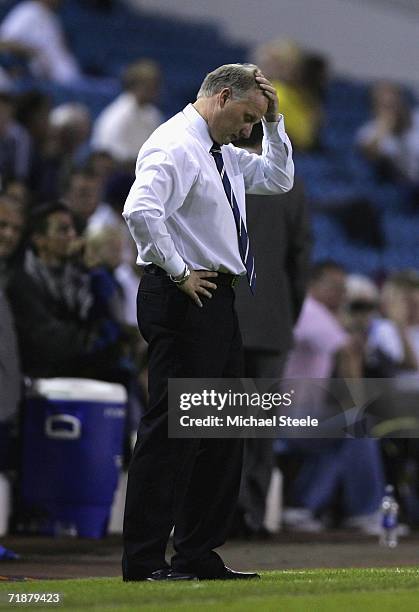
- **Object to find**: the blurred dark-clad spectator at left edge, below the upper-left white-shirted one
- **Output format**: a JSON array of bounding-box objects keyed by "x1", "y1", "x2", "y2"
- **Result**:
[{"x1": 0, "y1": 92, "x2": 30, "y2": 188}]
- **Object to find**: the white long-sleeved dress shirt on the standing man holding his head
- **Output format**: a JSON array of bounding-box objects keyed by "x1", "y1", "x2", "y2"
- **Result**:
[{"x1": 123, "y1": 104, "x2": 294, "y2": 276}]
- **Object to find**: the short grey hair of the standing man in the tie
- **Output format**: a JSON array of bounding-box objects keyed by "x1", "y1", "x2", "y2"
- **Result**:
[{"x1": 197, "y1": 64, "x2": 260, "y2": 98}]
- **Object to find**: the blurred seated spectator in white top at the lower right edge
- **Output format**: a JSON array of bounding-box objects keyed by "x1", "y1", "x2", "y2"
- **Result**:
[{"x1": 358, "y1": 270, "x2": 419, "y2": 524}]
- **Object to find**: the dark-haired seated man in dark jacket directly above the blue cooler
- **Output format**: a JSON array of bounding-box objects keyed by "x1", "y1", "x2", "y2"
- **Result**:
[{"x1": 8, "y1": 202, "x2": 124, "y2": 380}]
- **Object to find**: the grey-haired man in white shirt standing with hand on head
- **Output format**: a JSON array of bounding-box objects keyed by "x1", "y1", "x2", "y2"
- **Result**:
[{"x1": 122, "y1": 64, "x2": 294, "y2": 581}]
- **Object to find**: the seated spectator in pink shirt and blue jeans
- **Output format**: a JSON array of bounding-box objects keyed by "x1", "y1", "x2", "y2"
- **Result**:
[{"x1": 283, "y1": 261, "x2": 384, "y2": 533}]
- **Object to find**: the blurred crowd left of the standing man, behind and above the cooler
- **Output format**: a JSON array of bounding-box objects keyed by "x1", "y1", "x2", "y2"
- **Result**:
[{"x1": 0, "y1": 41, "x2": 167, "y2": 554}]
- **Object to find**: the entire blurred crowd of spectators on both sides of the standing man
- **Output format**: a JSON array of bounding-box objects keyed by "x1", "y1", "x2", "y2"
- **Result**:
[{"x1": 0, "y1": 0, "x2": 419, "y2": 535}]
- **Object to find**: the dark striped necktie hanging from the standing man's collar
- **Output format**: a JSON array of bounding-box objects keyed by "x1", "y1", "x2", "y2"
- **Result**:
[{"x1": 210, "y1": 143, "x2": 256, "y2": 294}]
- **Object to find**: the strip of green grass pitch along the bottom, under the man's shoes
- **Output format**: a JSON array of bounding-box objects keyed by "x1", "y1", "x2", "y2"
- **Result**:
[{"x1": 0, "y1": 568, "x2": 419, "y2": 612}]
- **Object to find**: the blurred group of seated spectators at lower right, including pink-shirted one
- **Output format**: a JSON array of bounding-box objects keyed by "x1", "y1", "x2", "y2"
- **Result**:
[{"x1": 276, "y1": 261, "x2": 419, "y2": 534}]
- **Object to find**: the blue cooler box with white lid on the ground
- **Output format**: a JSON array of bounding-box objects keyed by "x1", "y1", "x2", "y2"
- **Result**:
[{"x1": 22, "y1": 378, "x2": 127, "y2": 538}]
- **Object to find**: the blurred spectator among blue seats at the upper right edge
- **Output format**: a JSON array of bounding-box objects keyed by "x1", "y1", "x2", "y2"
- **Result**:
[{"x1": 356, "y1": 81, "x2": 419, "y2": 185}]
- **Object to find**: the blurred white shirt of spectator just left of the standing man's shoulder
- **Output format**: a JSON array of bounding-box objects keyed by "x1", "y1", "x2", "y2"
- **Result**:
[{"x1": 92, "y1": 92, "x2": 163, "y2": 162}]
